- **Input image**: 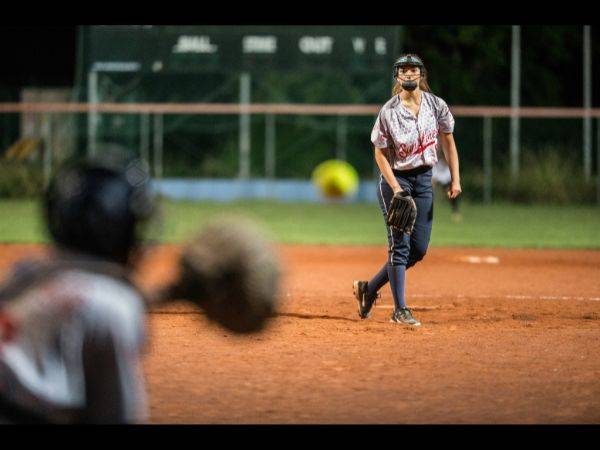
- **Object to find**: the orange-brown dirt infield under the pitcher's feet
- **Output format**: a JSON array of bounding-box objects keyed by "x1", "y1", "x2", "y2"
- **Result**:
[{"x1": 0, "y1": 245, "x2": 600, "y2": 423}]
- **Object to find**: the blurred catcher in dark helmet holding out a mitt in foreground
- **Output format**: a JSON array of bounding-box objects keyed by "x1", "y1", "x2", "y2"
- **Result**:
[{"x1": 0, "y1": 154, "x2": 279, "y2": 423}]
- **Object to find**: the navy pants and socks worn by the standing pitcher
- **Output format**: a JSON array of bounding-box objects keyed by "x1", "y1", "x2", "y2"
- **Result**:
[{"x1": 367, "y1": 166, "x2": 433, "y2": 308}]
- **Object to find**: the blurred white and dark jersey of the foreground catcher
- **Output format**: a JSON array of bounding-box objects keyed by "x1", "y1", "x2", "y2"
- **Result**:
[{"x1": 0, "y1": 255, "x2": 147, "y2": 423}]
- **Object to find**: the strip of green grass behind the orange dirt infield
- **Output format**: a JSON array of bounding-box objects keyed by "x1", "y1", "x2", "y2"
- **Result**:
[{"x1": 0, "y1": 200, "x2": 600, "y2": 248}]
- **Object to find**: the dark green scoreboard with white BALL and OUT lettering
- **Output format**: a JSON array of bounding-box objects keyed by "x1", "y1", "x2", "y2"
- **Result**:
[{"x1": 81, "y1": 25, "x2": 401, "y2": 74}]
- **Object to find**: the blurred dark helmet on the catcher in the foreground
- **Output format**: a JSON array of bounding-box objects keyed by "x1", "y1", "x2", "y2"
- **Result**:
[{"x1": 44, "y1": 156, "x2": 155, "y2": 264}]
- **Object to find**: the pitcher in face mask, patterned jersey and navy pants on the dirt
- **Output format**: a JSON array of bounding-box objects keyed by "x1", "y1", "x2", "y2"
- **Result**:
[{"x1": 354, "y1": 54, "x2": 461, "y2": 326}]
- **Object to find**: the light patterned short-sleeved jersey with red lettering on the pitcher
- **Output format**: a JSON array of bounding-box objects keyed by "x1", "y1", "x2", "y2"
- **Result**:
[{"x1": 371, "y1": 92, "x2": 454, "y2": 170}]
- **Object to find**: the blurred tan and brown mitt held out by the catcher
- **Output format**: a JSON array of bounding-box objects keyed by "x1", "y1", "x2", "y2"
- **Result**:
[{"x1": 165, "y1": 218, "x2": 280, "y2": 333}]
